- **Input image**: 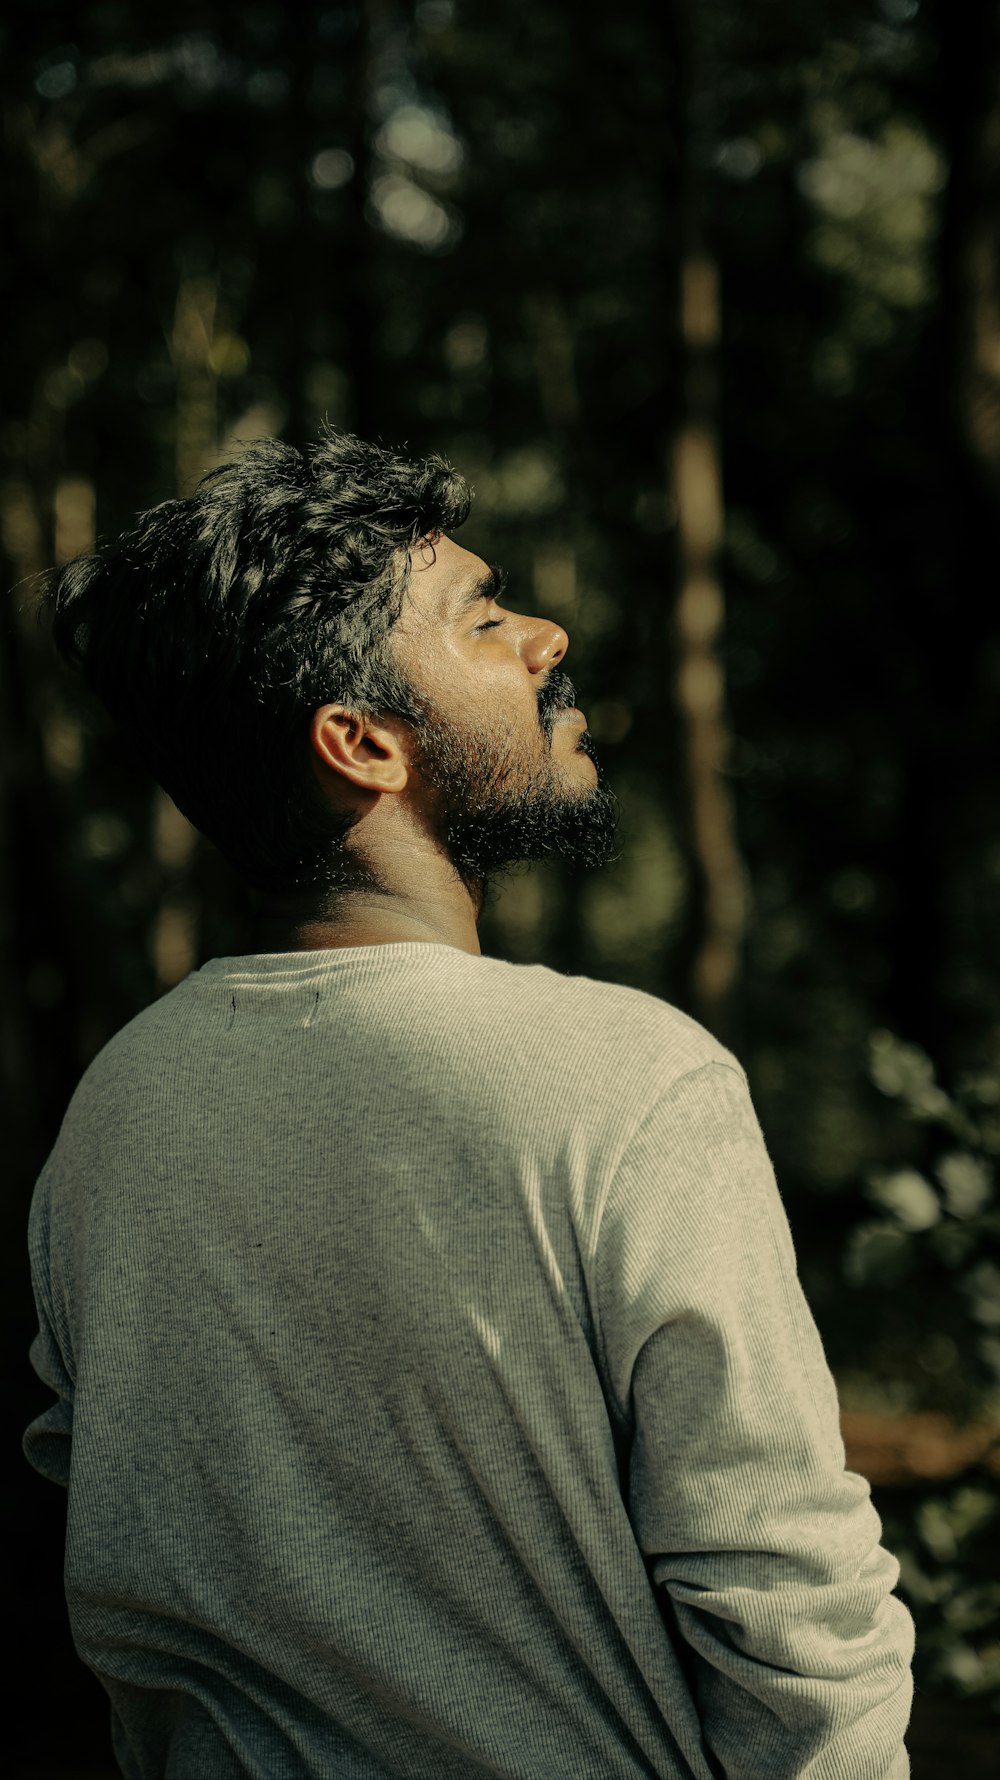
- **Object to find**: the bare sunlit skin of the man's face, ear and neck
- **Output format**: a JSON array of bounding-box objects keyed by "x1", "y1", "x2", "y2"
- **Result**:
[{"x1": 254, "y1": 534, "x2": 598, "y2": 954}]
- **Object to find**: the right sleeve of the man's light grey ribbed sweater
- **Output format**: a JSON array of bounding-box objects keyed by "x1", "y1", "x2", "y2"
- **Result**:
[{"x1": 598, "y1": 1063, "x2": 913, "y2": 1780}]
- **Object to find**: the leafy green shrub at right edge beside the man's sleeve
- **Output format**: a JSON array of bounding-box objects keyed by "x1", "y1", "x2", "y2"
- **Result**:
[{"x1": 843, "y1": 1031, "x2": 1000, "y2": 1711}]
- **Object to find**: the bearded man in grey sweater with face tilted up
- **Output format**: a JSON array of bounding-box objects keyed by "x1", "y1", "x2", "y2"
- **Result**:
[{"x1": 27, "y1": 434, "x2": 911, "y2": 1780}]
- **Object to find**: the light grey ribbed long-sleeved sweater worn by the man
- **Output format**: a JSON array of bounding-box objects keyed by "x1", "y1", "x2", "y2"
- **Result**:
[{"x1": 25, "y1": 943, "x2": 911, "y2": 1780}]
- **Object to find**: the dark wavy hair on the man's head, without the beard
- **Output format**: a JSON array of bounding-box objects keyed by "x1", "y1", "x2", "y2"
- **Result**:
[{"x1": 43, "y1": 427, "x2": 472, "y2": 894}]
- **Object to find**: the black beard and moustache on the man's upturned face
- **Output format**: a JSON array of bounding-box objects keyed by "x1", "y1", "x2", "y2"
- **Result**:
[{"x1": 405, "y1": 671, "x2": 617, "y2": 890}]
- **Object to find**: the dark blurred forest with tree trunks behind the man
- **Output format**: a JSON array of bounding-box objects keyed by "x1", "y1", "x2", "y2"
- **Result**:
[{"x1": 0, "y1": 0, "x2": 1000, "y2": 1780}]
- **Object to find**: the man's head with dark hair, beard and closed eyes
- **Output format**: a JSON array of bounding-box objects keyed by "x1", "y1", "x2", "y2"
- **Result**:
[{"x1": 48, "y1": 431, "x2": 614, "y2": 906}]
